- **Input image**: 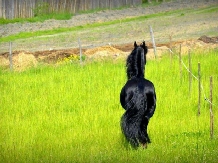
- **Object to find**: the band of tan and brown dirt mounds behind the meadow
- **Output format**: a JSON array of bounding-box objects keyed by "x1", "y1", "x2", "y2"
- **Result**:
[{"x1": 0, "y1": 36, "x2": 218, "y2": 71}]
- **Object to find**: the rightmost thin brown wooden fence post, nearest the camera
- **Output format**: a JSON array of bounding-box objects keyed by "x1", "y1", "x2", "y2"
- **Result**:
[{"x1": 210, "y1": 76, "x2": 214, "y2": 139}]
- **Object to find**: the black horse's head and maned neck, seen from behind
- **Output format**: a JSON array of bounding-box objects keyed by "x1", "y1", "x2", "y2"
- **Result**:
[{"x1": 126, "y1": 41, "x2": 148, "y2": 79}]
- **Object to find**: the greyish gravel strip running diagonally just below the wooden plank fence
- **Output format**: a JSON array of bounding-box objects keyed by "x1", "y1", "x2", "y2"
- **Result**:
[{"x1": 0, "y1": 0, "x2": 218, "y2": 37}]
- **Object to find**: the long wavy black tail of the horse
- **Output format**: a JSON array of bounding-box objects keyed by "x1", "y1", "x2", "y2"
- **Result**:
[{"x1": 121, "y1": 90, "x2": 147, "y2": 148}]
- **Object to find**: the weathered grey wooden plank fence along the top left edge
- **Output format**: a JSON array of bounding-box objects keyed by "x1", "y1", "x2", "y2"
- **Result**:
[{"x1": 0, "y1": 0, "x2": 142, "y2": 19}]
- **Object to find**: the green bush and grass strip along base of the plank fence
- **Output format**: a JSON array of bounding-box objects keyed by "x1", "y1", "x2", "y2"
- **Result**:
[{"x1": 0, "y1": 1, "x2": 169, "y2": 25}]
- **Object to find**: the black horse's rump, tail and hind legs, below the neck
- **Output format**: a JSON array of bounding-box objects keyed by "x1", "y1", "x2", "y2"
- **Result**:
[{"x1": 120, "y1": 78, "x2": 156, "y2": 148}]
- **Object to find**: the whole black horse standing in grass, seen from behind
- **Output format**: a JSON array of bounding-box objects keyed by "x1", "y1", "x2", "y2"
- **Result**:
[{"x1": 120, "y1": 41, "x2": 156, "y2": 148}]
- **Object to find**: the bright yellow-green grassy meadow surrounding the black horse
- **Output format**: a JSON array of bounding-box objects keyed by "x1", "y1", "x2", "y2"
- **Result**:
[{"x1": 0, "y1": 50, "x2": 218, "y2": 163}]
